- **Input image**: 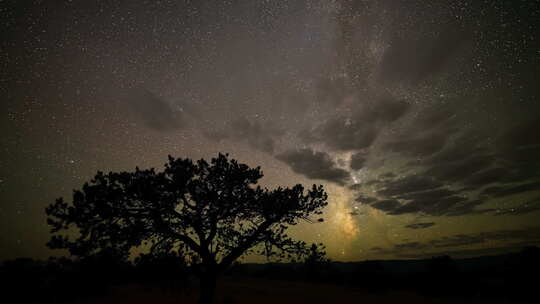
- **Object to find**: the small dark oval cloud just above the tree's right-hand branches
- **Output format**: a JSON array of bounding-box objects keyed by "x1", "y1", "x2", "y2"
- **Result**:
[{"x1": 276, "y1": 148, "x2": 350, "y2": 185}]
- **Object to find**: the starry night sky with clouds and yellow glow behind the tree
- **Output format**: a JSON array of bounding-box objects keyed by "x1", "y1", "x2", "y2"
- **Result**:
[{"x1": 0, "y1": 0, "x2": 540, "y2": 261}]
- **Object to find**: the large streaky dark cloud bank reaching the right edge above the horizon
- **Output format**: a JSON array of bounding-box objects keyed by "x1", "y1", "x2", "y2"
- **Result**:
[{"x1": 364, "y1": 103, "x2": 540, "y2": 216}]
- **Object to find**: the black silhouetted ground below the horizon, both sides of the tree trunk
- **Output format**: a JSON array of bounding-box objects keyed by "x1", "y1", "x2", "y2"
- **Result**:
[{"x1": 0, "y1": 247, "x2": 540, "y2": 304}]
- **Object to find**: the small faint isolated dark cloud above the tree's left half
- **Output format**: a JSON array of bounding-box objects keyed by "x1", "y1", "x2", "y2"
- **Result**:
[{"x1": 127, "y1": 89, "x2": 185, "y2": 131}]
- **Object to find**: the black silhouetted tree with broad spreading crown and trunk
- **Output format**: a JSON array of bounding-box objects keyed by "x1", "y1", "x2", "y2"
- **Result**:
[{"x1": 46, "y1": 154, "x2": 327, "y2": 303}]
